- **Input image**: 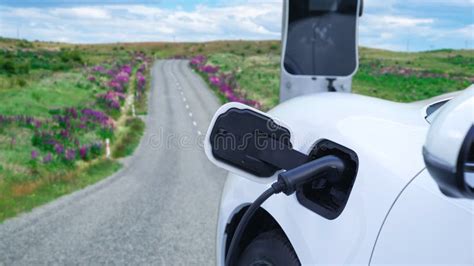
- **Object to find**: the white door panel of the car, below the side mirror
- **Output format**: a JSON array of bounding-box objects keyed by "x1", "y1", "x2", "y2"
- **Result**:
[{"x1": 371, "y1": 170, "x2": 474, "y2": 265}]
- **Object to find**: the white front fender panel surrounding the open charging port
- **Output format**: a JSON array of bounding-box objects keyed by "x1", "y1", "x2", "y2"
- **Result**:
[{"x1": 217, "y1": 93, "x2": 440, "y2": 265}]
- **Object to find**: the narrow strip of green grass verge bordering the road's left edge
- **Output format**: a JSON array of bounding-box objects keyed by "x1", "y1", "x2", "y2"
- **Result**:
[{"x1": 0, "y1": 160, "x2": 121, "y2": 223}]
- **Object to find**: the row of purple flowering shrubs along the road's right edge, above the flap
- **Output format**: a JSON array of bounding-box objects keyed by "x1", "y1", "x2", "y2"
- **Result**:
[{"x1": 190, "y1": 55, "x2": 261, "y2": 108}]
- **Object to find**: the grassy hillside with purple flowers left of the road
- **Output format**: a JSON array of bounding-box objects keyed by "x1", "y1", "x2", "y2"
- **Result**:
[{"x1": 0, "y1": 39, "x2": 152, "y2": 222}]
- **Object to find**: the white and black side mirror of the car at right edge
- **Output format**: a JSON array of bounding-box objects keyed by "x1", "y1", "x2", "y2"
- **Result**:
[{"x1": 423, "y1": 86, "x2": 474, "y2": 199}]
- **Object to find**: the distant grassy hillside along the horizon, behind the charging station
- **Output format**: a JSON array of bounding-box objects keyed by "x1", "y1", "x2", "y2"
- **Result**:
[{"x1": 51, "y1": 36, "x2": 466, "y2": 109}]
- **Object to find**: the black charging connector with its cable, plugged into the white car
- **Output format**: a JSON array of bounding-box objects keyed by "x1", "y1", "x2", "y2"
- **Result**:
[{"x1": 225, "y1": 155, "x2": 345, "y2": 266}]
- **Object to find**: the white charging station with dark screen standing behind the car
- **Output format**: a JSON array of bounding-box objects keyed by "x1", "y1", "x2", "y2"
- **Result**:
[{"x1": 280, "y1": 0, "x2": 363, "y2": 102}]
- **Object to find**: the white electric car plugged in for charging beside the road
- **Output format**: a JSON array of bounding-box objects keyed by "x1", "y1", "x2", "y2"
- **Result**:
[{"x1": 211, "y1": 87, "x2": 474, "y2": 265}]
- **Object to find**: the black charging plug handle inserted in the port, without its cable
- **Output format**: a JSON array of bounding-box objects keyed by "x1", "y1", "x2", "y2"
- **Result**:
[{"x1": 278, "y1": 155, "x2": 345, "y2": 196}]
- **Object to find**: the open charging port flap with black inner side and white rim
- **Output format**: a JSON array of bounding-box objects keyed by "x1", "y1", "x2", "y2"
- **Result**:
[{"x1": 206, "y1": 103, "x2": 309, "y2": 177}]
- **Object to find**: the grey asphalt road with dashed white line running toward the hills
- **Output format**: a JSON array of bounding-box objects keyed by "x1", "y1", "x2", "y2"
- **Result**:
[{"x1": 0, "y1": 60, "x2": 225, "y2": 265}]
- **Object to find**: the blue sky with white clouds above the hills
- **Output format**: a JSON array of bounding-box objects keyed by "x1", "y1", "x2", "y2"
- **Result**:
[{"x1": 0, "y1": 0, "x2": 474, "y2": 51}]
